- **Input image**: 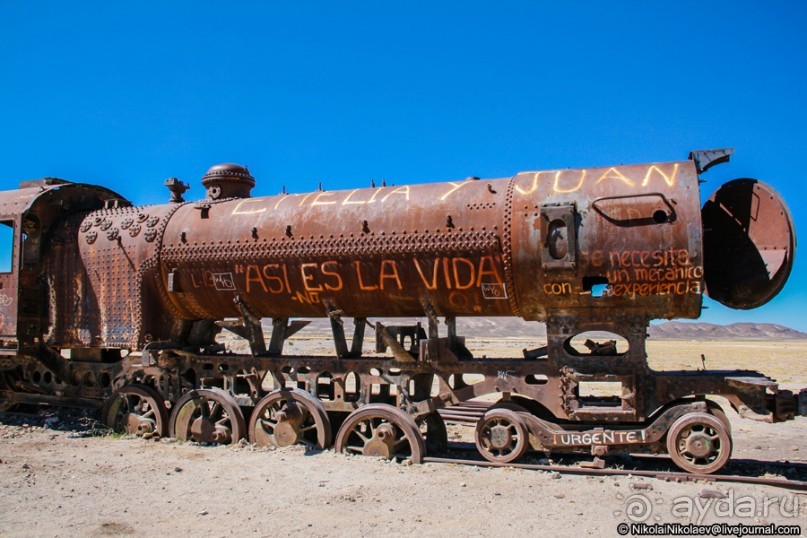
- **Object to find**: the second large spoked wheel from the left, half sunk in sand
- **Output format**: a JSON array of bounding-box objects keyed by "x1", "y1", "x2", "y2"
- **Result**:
[{"x1": 170, "y1": 389, "x2": 247, "y2": 445}]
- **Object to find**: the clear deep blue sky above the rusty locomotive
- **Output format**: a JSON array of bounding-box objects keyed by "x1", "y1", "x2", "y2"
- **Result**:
[{"x1": 0, "y1": 0, "x2": 807, "y2": 330}]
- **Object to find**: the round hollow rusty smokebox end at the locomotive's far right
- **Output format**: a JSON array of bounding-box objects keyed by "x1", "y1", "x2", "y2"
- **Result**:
[{"x1": 702, "y1": 179, "x2": 796, "y2": 309}]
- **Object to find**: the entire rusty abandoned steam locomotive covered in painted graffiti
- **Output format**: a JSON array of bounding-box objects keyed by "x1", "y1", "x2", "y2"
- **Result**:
[{"x1": 0, "y1": 150, "x2": 807, "y2": 473}]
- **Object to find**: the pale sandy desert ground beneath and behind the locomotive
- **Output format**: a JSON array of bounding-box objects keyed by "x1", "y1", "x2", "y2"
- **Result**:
[{"x1": 0, "y1": 340, "x2": 807, "y2": 537}]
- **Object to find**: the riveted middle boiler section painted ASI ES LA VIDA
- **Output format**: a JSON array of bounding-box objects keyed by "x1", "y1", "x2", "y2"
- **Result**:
[{"x1": 161, "y1": 179, "x2": 512, "y2": 317}]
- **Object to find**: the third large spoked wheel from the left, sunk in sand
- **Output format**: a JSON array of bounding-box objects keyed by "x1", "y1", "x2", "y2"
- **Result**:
[{"x1": 249, "y1": 389, "x2": 331, "y2": 450}]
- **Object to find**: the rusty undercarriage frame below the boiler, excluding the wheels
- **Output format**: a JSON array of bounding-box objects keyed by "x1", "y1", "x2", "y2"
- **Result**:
[{"x1": 0, "y1": 315, "x2": 804, "y2": 468}]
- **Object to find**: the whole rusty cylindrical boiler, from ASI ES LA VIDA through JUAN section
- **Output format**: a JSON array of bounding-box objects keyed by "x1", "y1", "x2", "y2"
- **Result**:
[{"x1": 159, "y1": 157, "x2": 716, "y2": 320}]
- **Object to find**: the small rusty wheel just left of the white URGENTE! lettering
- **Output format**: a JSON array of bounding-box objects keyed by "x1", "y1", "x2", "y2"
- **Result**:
[{"x1": 474, "y1": 408, "x2": 529, "y2": 463}]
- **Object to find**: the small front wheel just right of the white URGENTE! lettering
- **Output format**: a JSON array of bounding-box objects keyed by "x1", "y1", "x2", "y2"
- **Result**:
[{"x1": 667, "y1": 413, "x2": 731, "y2": 474}]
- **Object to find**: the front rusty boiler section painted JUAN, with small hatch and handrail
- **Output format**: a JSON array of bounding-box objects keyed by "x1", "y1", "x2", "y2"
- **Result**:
[{"x1": 516, "y1": 161, "x2": 703, "y2": 321}]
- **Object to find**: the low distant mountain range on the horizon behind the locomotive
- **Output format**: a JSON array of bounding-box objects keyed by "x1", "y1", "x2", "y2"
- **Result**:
[{"x1": 284, "y1": 318, "x2": 807, "y2": 340}]
